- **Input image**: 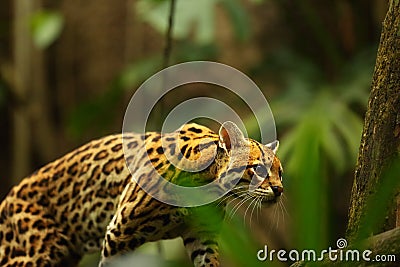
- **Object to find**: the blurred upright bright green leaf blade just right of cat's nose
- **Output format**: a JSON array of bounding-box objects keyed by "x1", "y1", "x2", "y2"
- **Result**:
[{"x1": 281, "y1": 116, "x2": 328, "y2": 249}]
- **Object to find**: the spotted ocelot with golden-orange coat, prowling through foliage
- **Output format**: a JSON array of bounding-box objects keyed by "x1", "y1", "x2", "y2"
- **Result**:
[{"x1": 0, "y1": 122, "x2": 283, "y2": 267}]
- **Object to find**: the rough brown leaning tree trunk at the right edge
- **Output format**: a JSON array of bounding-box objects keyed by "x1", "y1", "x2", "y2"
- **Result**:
[{"x1": 347, "y1": 0, "x2": 400, "y2": 241}]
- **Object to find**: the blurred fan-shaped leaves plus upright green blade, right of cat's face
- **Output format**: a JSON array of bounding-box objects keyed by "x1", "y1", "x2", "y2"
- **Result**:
[{"x1": 271, "y1": 49, "x2": 373, "y2": 249}]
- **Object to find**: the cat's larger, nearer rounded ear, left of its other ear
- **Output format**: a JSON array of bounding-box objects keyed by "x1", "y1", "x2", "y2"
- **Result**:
[{"x1": 219, "y1": 121, "x2": 246, "y2": 152}]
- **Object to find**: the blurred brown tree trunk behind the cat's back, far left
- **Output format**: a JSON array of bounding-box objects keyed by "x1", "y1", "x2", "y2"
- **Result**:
[{"x1": 12, "y1": 0, "x2": 56, "y2": 184}]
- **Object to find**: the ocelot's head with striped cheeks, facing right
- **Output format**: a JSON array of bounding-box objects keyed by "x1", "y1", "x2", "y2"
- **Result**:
[{"x1": 218, "y1": 122, "x2": 283, "y2": 203}]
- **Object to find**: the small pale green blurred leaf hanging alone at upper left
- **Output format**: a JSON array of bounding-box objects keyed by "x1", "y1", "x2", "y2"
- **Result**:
[{"x1": 31, "y1": 10, "x2": 64, "y2": 49}]
